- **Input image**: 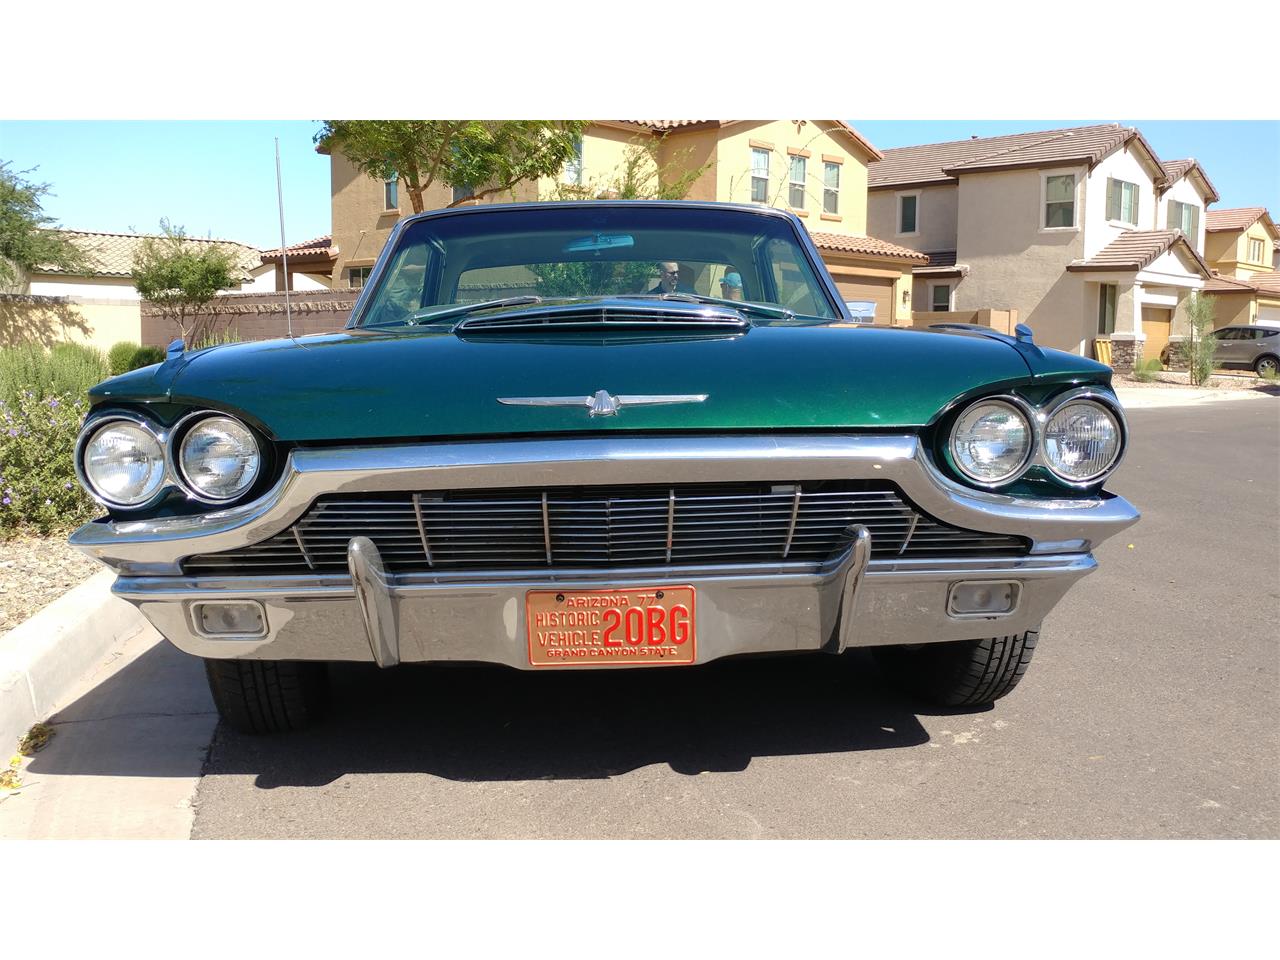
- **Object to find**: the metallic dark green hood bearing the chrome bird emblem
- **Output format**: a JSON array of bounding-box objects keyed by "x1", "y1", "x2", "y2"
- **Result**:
[{"x1": 91, "y1": 324, "x2": 1107, "y2": 443}]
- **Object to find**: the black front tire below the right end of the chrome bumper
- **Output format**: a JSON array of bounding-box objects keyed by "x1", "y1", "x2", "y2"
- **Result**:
[{"x1": 873, "y1": 628, "x2": 1039, "y2": 707}]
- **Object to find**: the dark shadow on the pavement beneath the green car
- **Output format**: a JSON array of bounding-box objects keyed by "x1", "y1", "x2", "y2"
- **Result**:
[{"x1": 20, "y1": 643, "x2": 952, "y2": 788}]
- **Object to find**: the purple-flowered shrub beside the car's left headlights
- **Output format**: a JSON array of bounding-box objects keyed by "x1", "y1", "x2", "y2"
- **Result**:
[{"x1": 0, "y1": 390, "x2": 100, "y2": 538}]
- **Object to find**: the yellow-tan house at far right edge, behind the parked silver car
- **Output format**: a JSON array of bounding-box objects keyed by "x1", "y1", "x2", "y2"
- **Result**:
[{"x1": 1204, "y1": 206, "x2": 1280, "y2": 326}]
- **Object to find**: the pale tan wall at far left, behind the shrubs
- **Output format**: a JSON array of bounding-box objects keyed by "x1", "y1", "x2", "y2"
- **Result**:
[{"x1": 0, "y1": 297, "x2": 142, "y2": 351}]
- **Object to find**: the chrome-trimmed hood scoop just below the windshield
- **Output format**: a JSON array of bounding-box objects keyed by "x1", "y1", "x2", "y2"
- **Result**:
[{"x1": 453, "y1": 303, "x2": 751, "y2": 334}]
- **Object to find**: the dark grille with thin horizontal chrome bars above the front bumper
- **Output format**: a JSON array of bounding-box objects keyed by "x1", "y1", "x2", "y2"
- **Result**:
[{"x1": 183, "y1": 481, "x2": 1028, "y2": 575}]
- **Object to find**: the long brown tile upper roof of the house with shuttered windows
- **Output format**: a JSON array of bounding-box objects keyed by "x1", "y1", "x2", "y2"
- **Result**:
[{"x1": 867, "y1": 123, "x2": 1158, "y2": 189}]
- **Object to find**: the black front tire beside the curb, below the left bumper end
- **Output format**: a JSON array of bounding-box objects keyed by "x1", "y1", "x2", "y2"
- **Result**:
[{"x1": 205, "y1": 659, "x2": 329, "y2": 733}]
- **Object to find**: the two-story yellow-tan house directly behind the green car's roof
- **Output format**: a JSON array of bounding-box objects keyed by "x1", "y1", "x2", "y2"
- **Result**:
[{"x1": 316, "y1": 120, "x2": 927, "y2": 325}]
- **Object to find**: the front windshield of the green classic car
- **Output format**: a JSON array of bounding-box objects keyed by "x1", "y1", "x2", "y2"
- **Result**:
[{"x1": 358, "y1": 205, "x2": 840, "y2": 326}]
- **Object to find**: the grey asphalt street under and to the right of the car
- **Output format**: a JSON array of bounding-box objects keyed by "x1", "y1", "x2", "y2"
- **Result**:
[{"x1": 12, "y1": 399, "x2": 1280, "y2": 838}]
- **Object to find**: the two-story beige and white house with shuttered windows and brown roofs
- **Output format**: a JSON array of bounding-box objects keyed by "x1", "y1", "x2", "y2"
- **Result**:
[{"x1": 868, "y1": 124, "x2": 1219, "y2": 367}]
